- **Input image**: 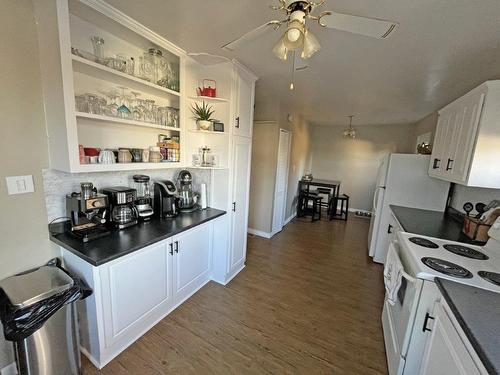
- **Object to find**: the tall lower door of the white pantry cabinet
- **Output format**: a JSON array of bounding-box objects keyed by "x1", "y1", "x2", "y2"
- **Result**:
[{"x1": 229, "y1": 137, "x2": 252, "y2": 273}]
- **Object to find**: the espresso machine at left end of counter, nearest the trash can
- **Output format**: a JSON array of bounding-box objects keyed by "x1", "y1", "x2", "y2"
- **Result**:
[{"x1": 66, "y1": 182, "x2": 110, "y2": 242}]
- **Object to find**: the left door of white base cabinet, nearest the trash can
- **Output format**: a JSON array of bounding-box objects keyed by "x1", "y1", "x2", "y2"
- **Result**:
[{"x1": 100, "y1": 241, "x2": 173, "y2": 346}]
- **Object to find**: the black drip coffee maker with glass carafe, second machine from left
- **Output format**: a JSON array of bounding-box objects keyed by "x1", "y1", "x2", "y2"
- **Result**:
[{"x1": 102, "y1": 186, "x2": 139, "y2": 229}]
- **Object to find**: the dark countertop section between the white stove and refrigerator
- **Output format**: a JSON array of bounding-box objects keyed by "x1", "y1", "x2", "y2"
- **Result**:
[{"x1": 390, "y1": 205, "x2": 483, "y2": 245}]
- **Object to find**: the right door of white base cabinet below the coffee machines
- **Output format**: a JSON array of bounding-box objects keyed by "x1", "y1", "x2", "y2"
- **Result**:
[{"x1": 169, "y1": 224, "x2": 212, "y2": 302}]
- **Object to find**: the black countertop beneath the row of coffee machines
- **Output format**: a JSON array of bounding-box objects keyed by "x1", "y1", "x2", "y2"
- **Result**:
[{"x1": 49, "y1": 208, "x2": 226, "y2": 266}]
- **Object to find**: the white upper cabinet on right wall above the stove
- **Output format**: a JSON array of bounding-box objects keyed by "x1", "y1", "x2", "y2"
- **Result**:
[{"x1": 429, "y1": 81, "x2": 500, "y2": 188}]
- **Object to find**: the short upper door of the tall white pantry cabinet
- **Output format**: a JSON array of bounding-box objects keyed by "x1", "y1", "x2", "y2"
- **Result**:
[{"x1": 233, "y1": 69, "x2": 255, "y2": 137}]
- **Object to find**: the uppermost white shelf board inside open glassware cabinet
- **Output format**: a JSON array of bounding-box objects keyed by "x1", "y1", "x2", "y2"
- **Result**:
[{"x1": 71, "y1": 54, "x2": 181, "y2": 98}]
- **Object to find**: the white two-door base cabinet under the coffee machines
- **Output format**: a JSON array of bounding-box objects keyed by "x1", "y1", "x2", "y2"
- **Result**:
[{"x1": 62, "y1": 220, "x2": 213, "y2": 368}]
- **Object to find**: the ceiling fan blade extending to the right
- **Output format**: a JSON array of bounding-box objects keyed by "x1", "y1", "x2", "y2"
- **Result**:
[{"x1": 318, "y1": 12, "x2": 399, "y2": 39}]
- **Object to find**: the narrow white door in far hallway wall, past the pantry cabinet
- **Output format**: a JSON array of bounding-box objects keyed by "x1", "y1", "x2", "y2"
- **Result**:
[{"x1": 273, "y1": 129, "x2": 291, "y2": 233}]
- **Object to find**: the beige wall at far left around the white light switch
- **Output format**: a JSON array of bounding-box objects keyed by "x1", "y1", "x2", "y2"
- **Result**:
[{"x1": 0, "y1": 0, "x2": 59, "y2": 369}]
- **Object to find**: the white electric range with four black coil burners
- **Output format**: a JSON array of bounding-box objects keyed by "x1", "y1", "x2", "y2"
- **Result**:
[{"x1": 382, "y1": 219, "x2": 500, "y2": 375}]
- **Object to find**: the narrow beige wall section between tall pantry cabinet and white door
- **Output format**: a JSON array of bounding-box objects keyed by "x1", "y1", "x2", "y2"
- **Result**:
[{"x1": 248, "y1": 121, "x2": 279, "y2": 233}]
